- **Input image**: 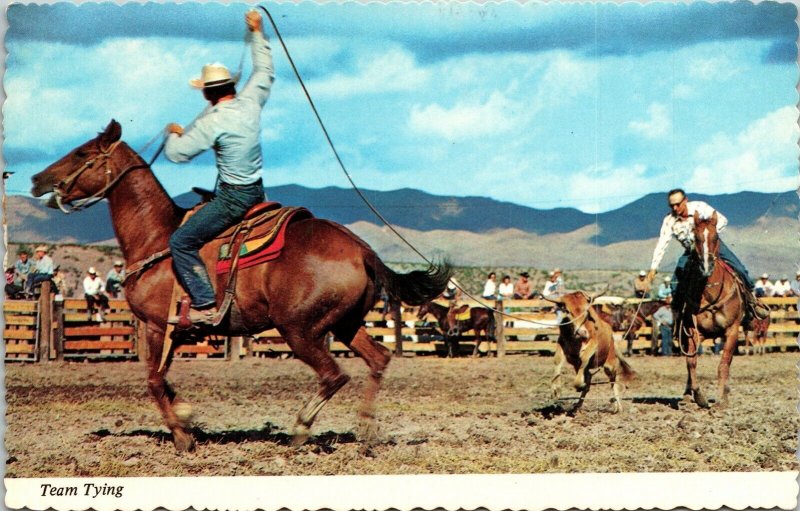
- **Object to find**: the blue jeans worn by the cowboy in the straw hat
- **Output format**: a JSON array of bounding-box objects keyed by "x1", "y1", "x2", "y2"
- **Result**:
[{"x1": 169, "y1": 179, "x2": 265, "y2": 309}]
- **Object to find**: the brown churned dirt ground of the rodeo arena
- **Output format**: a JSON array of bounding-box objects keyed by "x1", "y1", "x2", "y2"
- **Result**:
[{"x1": 6, "y1": 353, "x2": 800, "y2": 477}]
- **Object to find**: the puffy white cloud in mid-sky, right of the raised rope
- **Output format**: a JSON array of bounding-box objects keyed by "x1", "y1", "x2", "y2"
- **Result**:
[{"x1": 408, "y1": 92, "x2": 516, "y2": 141}]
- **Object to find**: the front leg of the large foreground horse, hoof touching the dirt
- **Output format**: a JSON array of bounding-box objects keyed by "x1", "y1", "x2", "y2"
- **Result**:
[{"x1": 147, "y1": 324, "x2": 194, "y2": 451}]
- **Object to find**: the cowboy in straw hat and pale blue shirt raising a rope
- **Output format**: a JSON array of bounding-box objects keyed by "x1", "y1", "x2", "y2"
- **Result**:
[{"x1": 165, "y1": 10, "x2": 275, "y2": 324}]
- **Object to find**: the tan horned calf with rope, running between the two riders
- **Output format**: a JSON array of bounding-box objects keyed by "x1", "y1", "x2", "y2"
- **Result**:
[{"x1": 549, "y1": 291, "x2": 636, "y2": 413}]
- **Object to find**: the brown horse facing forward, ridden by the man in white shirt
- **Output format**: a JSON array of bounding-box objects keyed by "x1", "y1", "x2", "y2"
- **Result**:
[{"x1": 677, "y1": 213, "x2": 746, "y2": 408}]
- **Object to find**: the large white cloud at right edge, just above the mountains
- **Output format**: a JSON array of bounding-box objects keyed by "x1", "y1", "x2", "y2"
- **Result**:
[{"x1": 686, "y1": 106, "x2": 800, "y2": 193}]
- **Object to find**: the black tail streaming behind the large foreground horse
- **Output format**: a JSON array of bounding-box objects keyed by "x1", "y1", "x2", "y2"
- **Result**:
[{"x1": 365, "y1": 252, "x2": 453, "y2": 305}]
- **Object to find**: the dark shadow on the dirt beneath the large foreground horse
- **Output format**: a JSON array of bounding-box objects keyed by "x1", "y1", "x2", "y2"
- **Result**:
[{"x1": 91, "y1": 422, "x2": 356, "y2": 454}]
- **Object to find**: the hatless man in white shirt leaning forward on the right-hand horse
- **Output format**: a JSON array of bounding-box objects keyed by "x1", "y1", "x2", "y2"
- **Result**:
[{"x1": 647, "y1": 188, "x2": 769, "y2": 324}]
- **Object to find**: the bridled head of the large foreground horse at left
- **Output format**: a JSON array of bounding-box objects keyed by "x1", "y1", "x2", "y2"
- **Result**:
[{"x1": 31, "y1": 119, "x2": 122, "y2": 211}]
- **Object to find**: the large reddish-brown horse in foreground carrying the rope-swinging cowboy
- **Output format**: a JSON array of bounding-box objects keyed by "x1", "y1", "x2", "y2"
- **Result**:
[{"x1": 32, "y1": 120, "x2": 451, "y2": 451}]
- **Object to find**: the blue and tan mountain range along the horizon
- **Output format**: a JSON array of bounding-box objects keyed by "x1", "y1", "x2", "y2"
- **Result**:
[{"x1": 7, "y1": 185, "x2": 800, "y2": 271}]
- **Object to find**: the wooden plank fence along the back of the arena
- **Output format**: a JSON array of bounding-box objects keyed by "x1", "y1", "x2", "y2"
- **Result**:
[{"x1": 3, "y1": 293, "x2": 800, "y2": 362}]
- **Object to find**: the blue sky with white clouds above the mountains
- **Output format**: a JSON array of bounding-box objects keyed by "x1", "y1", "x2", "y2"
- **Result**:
[{"x1": 3, "y1": 2, "x2": 800, "y2": 213}]
